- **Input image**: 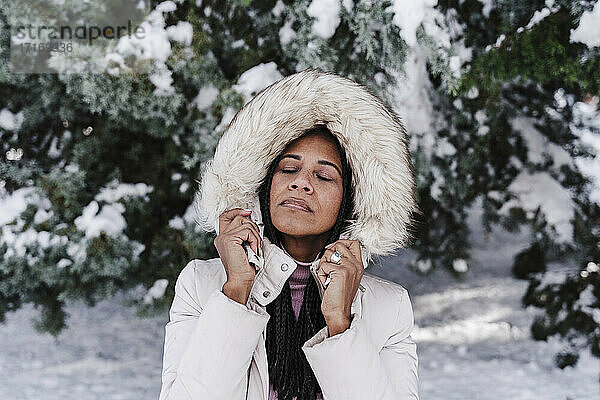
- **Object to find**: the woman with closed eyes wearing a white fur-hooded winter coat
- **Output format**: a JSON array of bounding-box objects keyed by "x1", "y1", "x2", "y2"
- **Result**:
[{"x1": 160, "y1": 69, "x2": 419, "y2": 400}]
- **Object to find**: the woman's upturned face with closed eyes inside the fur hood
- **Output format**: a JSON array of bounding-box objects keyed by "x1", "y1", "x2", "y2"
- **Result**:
[{"x1": 270, "y1": 133, "x2": 343, "y2": 238}]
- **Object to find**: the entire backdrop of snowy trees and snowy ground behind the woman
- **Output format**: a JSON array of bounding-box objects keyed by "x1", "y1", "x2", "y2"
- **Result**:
[{"x1": 0, "y1": 0, "x2": 600, "y2": 400}]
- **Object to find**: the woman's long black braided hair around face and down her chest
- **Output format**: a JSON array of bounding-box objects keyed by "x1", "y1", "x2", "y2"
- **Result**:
[{"x1": 258, "y1": 125, "x2": 354, "y2": 400}]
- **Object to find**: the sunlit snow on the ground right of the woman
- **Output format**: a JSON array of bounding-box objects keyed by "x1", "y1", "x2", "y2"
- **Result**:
[{"x1": 372, "y1": 198, "x2": 600, "y2": 400}]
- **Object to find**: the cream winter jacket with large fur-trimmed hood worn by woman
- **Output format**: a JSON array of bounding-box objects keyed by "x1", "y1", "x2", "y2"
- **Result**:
[{"x1": 159, "y1": 69, "x2": 419, "y2": 400}]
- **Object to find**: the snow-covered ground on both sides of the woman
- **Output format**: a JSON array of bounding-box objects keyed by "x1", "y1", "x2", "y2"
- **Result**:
[{"x1": 0, "y1": 203, "x2": 600, "y2": 400}]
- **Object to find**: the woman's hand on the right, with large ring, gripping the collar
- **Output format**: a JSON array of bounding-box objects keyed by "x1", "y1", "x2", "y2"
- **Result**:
[{"x1": 317, "y1": 239, "x2": 365, "y2": 336}]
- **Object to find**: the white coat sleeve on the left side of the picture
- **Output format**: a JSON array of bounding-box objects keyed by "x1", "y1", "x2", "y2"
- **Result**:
[{"x1": 159, "y1": 260, "x2": 269, "y2": 400}]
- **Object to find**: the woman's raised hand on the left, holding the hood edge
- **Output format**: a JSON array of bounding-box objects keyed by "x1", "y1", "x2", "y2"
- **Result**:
[{"x1": 214, "y1": 208, "x2": 262, "y2": 304}]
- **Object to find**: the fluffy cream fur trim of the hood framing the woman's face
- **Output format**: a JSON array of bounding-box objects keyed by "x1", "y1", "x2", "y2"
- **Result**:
[{"x1": 194, "y1": 69, "x2": 419, "y2": 260}]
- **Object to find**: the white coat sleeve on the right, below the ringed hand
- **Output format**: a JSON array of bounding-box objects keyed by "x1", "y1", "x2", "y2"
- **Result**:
[{"x1": 302, "y1": 288, "x2": 419, "y2": 400}]
